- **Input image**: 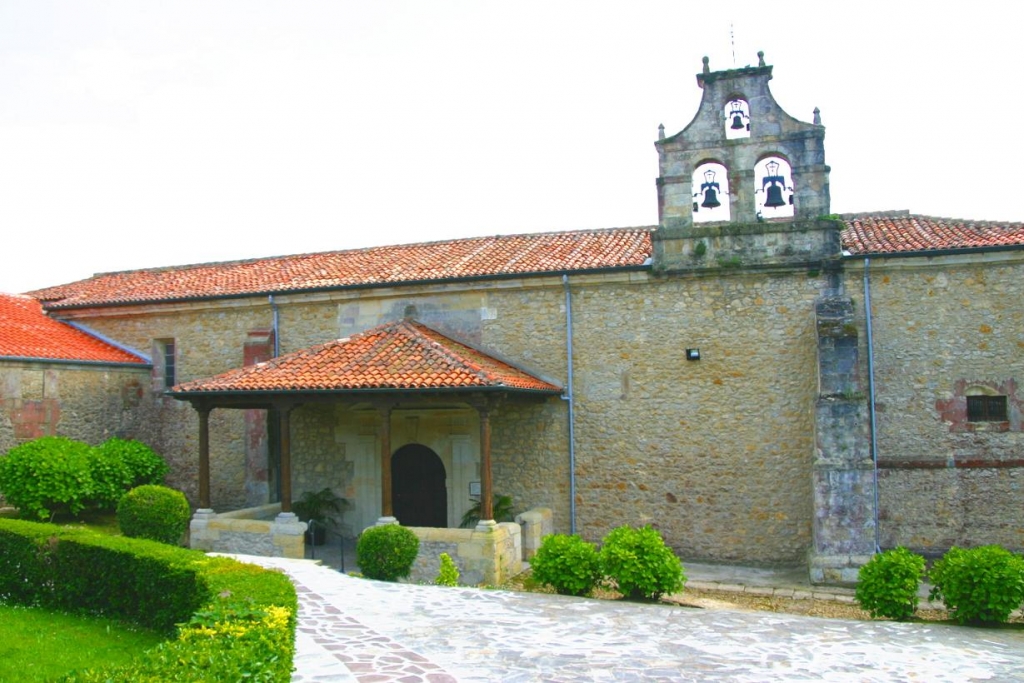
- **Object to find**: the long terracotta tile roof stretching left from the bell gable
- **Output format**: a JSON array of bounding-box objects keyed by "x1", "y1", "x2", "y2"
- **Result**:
[{"x1": 31, "y1": 227, "x2": 652, "y2": 308}]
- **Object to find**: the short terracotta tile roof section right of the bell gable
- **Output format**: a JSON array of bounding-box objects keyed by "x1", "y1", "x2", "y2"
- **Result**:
[{"x1": 841, "y1": 211, "x2": 1024, "y2": 256}]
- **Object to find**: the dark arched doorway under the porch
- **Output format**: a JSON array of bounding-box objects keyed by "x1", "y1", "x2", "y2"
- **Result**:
[{"x1": 391, "y1": 443, "x2": 447, "y2": 527}]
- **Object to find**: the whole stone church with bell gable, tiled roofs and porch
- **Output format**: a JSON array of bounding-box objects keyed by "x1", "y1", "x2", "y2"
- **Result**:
[{"x1": 0, "y1": 54, "x2": 1024, "y2": 583}]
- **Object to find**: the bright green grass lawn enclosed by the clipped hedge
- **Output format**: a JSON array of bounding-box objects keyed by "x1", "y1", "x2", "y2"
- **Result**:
[{"x1": 0, "y1": 604, "x2": 165, "y2": 681}]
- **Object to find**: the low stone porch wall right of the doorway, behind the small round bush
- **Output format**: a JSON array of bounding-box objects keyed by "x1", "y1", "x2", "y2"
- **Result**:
[{"x1": 409, "y1": 522, "x2": 522, "y2": 586}]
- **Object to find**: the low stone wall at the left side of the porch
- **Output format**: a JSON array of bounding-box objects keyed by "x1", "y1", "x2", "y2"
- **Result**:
[{"x1": 189, "y1": 503, "x2": 306, "y2": 559}]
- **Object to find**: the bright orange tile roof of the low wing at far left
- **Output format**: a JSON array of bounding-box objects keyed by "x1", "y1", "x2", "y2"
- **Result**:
[{"x1": 0, "y1": 294, "x2": 146, "y2": 365}]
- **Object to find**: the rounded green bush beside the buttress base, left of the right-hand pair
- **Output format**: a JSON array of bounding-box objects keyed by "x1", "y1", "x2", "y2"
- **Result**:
[{"x1": 854, "y1": 547, "x2": 925, "y2": 622}]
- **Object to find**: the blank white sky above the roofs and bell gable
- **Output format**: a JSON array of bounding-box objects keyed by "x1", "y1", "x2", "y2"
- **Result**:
[{"x1": 0, "y1": 0, "x2": 1024, "y2": 292}]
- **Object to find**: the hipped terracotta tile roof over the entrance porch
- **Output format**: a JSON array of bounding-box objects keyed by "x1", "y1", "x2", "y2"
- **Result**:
[{"x1": 171, "y1": 319, "x2": 561, "y2": 396}]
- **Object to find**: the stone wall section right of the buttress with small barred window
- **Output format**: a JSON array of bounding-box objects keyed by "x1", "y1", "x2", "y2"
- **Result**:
[{"x1": 847, "y1": 252, "x2": 1024, "y2": 555}]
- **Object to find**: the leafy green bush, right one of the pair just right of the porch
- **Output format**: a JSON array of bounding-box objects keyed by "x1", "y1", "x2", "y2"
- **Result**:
[{"x1": 600, "y1": 525, "x2": 686, "y2": 600}]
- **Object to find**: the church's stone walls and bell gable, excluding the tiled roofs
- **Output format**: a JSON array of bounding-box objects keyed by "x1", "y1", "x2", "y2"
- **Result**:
[{"x1": 6, "y1": 60, "x2": 1024, "y2": 583}]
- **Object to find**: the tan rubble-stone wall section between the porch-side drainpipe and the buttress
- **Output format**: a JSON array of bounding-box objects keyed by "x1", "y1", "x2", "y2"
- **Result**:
[{"x1": 573, "y1": 272, "x2": 823, "y2": 564}]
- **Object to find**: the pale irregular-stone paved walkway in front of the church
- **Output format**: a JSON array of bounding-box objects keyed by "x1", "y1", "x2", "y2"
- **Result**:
[{"x1": 239, "y1": 557, "x2": 1024, "y2": 683}]
